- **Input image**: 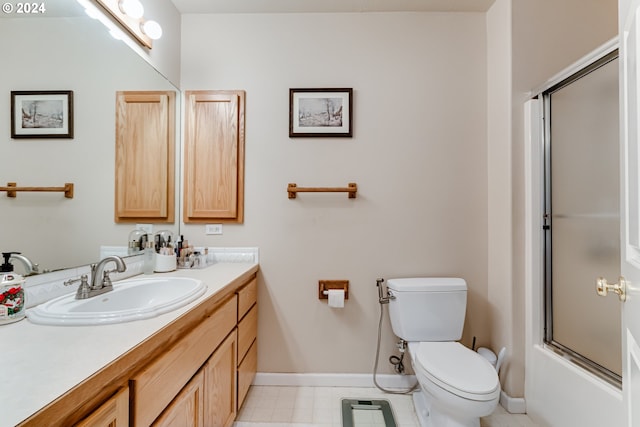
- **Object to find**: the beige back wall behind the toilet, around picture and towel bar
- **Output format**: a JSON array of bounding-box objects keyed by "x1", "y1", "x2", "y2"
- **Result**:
[{"x1": 181, "y1": 13, "x2": 491, "y2": 373}]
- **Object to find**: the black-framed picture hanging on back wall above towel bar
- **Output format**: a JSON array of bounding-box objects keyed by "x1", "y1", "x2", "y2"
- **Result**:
[{"x1": 289, "y1": 88, "x2": 353, "y2": 138}]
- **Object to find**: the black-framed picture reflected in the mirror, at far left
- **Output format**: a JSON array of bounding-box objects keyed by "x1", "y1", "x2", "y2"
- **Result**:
[{"x1": 11, "y1": 90, "x2": 73, "y2": 139}]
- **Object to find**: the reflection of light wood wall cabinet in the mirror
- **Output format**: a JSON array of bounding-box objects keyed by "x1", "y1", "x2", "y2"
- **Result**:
[{"x1": 115, "y1": 91, "x2": 175, "y2": 222}]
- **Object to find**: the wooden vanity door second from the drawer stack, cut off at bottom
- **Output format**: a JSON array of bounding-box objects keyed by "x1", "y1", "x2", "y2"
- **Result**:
[{"x1": 152, "y1": 370, "x2": 205, "y2": 427}]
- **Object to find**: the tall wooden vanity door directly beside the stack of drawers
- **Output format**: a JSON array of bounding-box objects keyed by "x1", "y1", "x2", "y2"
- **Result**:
[{"x1": 204, "y1": 330, "x2": 238, "y2": 427}]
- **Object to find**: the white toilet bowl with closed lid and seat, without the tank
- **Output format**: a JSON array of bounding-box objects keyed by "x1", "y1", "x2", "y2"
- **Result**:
[{"x1": 409, "y1": 342, "x2": 500, "y2": 427}]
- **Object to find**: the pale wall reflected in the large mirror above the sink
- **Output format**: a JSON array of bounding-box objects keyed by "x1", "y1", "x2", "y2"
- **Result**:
[{"x1": 0, "y1": 0, "x2": 180, "y2": 273}]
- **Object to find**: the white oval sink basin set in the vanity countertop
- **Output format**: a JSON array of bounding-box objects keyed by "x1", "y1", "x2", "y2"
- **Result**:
[{"x1": 27, "y1": 277, "x2": 207, "y2": 326}]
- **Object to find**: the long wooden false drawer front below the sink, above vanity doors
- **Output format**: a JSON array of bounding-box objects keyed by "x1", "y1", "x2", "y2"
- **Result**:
[{"x1": 130, "y1": 295, "x2": 237, "y2": 426}]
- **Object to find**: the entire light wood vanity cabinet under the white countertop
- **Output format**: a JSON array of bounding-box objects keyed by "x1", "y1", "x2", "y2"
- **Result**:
[{"x1": 19, "y1": 267, "x2": 257, "y2": 427}]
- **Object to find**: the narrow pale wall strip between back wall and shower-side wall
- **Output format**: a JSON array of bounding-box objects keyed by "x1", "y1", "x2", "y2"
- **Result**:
[{"x1": 487, "y1": 0, "x2": 524, "y2": 396}]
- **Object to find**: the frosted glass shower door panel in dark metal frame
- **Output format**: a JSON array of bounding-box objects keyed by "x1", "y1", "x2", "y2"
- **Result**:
[{"x1": 544, "y1": 52, "x2": 622, "y2": 384}]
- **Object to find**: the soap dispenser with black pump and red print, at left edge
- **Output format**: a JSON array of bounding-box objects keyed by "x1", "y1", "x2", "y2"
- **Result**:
[{"x1": 0, "y1": 252, "x2": 25, "y2": 325}]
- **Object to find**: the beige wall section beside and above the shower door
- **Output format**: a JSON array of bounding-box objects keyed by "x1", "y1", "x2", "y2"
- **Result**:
[{"x1": 487, "y1": 0, "x2": 617, "y2": 397}]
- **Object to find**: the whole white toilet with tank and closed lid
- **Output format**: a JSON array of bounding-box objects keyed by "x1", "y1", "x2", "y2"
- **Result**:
[{"x1": 387, "y1": 277, "x2": 500, "y2": 427}]
